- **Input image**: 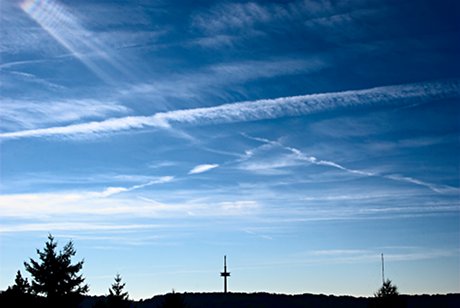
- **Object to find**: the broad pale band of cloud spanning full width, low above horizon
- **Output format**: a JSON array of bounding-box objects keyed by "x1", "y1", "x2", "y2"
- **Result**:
[{"x1": 0, "y1": 183, "x2": 459, "y2": 232}]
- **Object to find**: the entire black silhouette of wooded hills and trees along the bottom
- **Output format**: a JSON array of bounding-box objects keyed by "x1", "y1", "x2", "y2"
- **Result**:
[{"x1": 0, "y1": 234, "x2": 460, "y2": 308}]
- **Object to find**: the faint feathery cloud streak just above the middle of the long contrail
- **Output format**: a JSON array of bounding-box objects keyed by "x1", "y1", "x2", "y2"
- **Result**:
[{"x1": 120, "y1": 55, "x2": 328, "y2": 103}]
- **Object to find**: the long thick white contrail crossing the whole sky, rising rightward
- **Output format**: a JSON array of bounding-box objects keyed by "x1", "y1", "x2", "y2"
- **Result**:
[{"x1": 0, "y1": 80, "x2": 460, "y2": 139}]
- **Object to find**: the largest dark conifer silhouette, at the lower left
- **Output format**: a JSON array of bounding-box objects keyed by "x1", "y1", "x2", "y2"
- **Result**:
[{"x1": 24, "y1": 234, "x2": 89, "y2": 300}]
